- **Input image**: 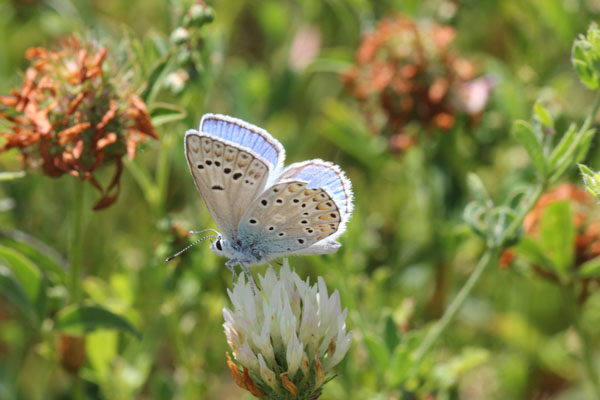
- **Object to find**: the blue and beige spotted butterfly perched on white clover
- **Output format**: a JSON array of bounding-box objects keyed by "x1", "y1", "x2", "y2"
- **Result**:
[{"x1": 180, "y1": 114, "x2": 353, "y2": 275}]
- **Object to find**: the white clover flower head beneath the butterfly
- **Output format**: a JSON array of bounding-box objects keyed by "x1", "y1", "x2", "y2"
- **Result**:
[{"x1": 223, "y1": 259, "x2": 352, "y2": 399}]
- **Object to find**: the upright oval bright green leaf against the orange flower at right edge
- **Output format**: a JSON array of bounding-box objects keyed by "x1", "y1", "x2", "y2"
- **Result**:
[{"x1": 540, "y1": 200, "x2": 575, "y2": 275}]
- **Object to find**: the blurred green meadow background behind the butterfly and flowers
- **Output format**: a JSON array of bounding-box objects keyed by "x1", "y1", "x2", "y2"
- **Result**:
[{"x1": 0, "y1": 0, "x2": 600, "y2": 400}]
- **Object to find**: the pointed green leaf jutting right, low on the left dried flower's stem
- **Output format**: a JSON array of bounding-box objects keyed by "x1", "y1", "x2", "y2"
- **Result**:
[{"x1": 54, "y1": 305, "x2": 141, "y2": 339}]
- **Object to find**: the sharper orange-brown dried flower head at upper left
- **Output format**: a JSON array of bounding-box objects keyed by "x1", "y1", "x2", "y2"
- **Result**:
[{"x1": 0, "y1": 37, "x2": 158, "y2": 209}]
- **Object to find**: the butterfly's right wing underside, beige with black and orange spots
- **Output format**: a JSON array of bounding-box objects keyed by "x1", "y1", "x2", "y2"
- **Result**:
[{"x1": 238, "y1": 181, "x2": 342, "y2": 258}]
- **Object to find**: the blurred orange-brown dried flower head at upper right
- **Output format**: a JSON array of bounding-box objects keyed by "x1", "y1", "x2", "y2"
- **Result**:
[{"x1": 342, "y1": 16, "x2": 475, "y2": 151}]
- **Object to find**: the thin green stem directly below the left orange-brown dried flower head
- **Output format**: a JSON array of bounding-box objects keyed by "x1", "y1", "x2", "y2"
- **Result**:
[{"x1": 69, "y1": 181, "x2": 84, "y2": 303}]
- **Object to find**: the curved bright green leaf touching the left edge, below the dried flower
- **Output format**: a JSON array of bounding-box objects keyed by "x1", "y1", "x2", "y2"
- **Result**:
[{"x1": 0, "y1": 246, "x2": 46, "y2": 317}]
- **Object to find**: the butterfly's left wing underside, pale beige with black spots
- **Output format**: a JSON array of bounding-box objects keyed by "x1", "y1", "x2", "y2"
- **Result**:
[{"x1": 185, "y1": 131, "x2": 269, "y2": 238}]
